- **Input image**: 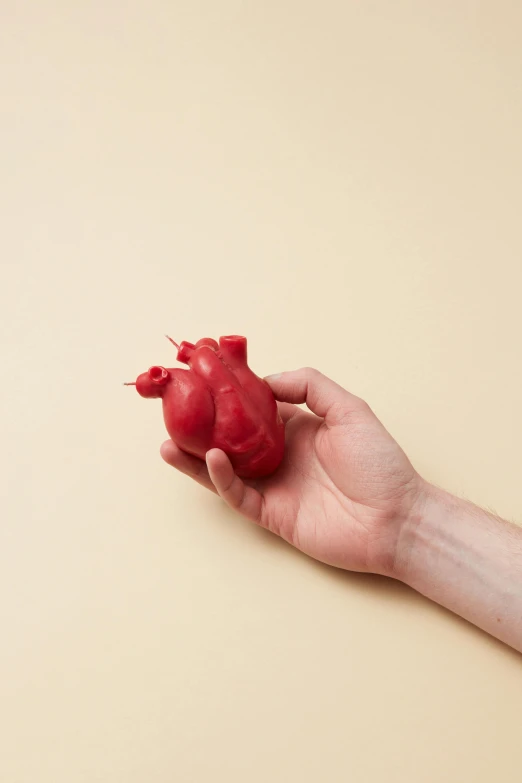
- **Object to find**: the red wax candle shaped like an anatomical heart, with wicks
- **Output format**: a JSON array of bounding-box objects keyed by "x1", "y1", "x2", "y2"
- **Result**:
[{"x1": 128, "y1": 335, "x2": 285, "y2": 478}]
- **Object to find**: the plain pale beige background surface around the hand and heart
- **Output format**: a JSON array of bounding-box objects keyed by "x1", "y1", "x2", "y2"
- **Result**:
[{"x1": 0, "y1": 0, "x2": 522, "y2": 783}]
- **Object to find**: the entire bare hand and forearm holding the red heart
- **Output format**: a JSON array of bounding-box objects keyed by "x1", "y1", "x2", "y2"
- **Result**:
[{"x1": 161, "y1": 368, "x2": 522, "y2": 652}]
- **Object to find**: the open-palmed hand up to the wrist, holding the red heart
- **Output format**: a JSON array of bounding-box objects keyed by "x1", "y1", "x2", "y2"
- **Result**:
[{"x1": 161, "y1": 368, "x2": 424, "y2": 576}]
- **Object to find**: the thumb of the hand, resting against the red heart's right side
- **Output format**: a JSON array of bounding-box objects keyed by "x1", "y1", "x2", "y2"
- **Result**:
[{"x1": 265, "y1": 367, "x2": 368, "y2": 425}]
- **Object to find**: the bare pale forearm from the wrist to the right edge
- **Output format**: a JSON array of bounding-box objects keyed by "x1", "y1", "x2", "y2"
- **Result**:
[{"x1": 396, "y1": 485, "x2": 522, "y2": 652}]
